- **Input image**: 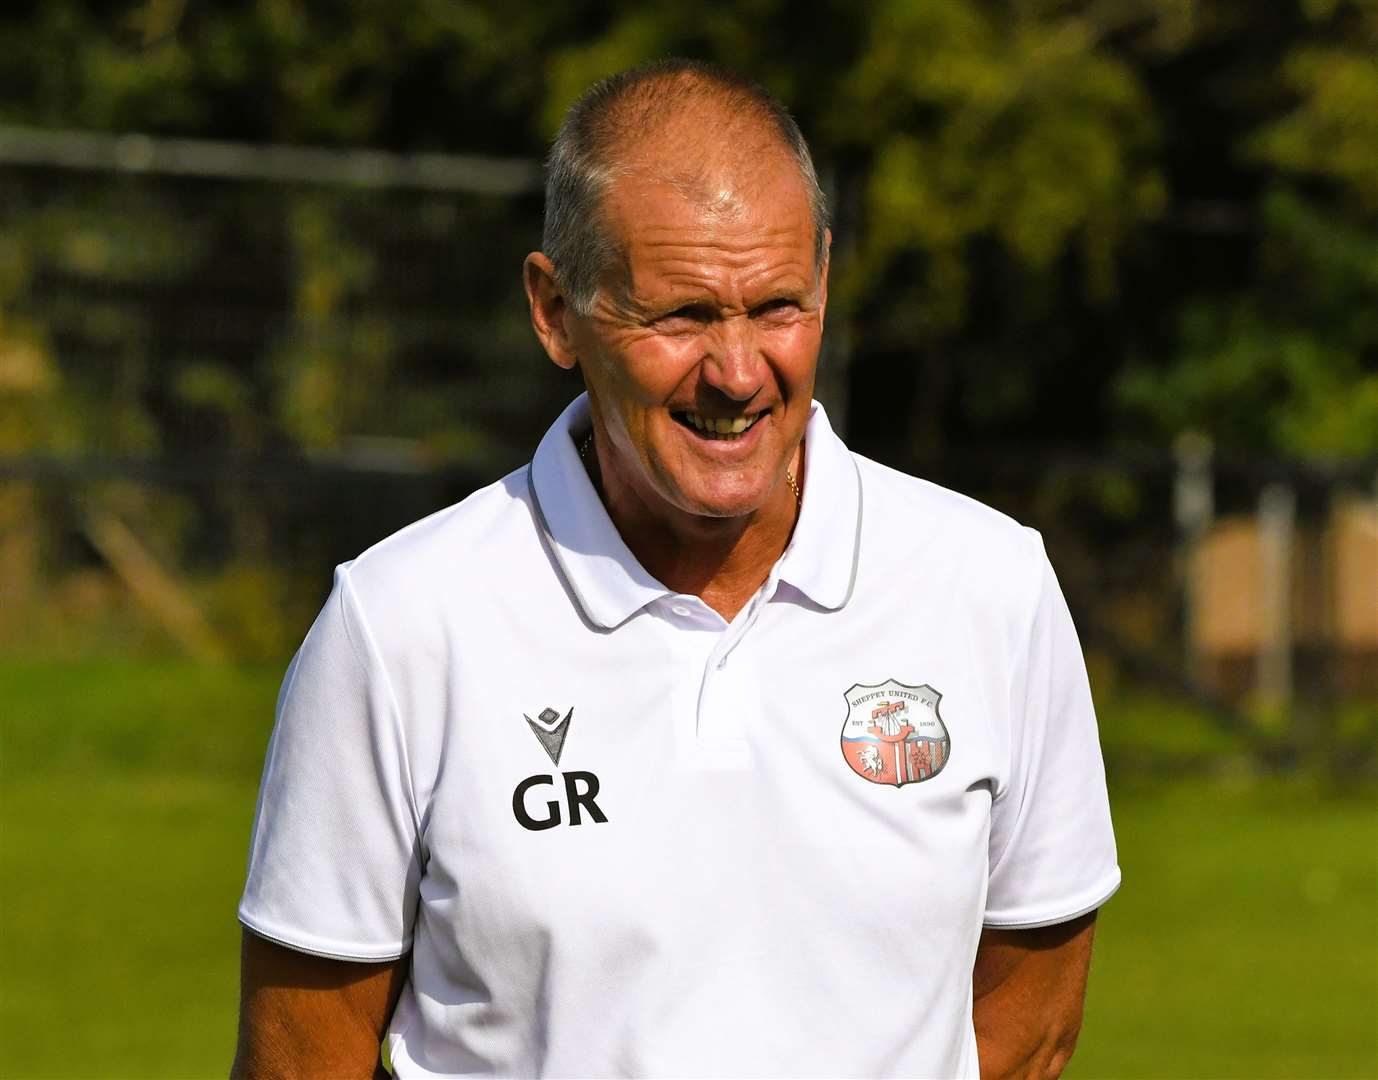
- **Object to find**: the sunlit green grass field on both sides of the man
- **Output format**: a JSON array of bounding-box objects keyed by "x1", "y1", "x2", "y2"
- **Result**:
[{"x1": 0, "y1": 661, "x2": 1378, "y2": 1077}]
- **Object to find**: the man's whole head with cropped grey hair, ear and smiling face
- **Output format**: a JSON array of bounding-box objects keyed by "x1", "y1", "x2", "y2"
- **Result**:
[{"x1": 526, "y1": 61, "x2": 828, "y2": 526}]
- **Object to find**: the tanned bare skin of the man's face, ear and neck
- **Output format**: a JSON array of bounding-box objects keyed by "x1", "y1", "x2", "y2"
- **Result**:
[{"x1": 526, "y1": 124, "x2": 827, "y2": 619}]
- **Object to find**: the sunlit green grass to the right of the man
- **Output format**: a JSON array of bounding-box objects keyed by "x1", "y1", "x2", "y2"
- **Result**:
[{"x1": 1067, "y1": 781, "x2": 1378, "y2": 1077}]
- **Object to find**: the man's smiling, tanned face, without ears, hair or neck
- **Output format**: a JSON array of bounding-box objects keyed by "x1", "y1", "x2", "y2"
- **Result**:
[{"x1": 569, "y1": 152, "x2": 827, "y2": 518}]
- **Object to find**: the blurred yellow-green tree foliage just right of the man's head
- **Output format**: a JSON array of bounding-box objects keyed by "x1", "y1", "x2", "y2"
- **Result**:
[{"x1": 823, "y1": 0, "x2": 1163, "y2": 344}]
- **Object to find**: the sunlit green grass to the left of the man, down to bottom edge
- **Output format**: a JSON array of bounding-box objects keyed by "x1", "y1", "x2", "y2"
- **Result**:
[{"x1": 0, "y1": 661, "x2": 280, "y2": 1077}]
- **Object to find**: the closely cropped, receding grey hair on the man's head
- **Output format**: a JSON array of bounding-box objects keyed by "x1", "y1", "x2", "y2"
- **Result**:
[{"x1": 540, "y1": 58, "x2": 828, "y2": 315}]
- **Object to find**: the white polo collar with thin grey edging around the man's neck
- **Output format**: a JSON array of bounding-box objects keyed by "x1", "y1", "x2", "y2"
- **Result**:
[{"x1": 526, "y1": 394, "x2": 861, "y2": 630}]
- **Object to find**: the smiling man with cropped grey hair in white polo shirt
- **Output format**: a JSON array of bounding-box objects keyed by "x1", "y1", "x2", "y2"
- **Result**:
[{"x1": 236, "y1": 62, "x2": 1119, "y2": 1076}]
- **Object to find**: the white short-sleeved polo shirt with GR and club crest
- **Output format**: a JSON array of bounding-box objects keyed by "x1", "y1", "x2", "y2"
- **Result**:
[{"x1": 240, "y1": 398, "x2": 1119, "y2": 1077}]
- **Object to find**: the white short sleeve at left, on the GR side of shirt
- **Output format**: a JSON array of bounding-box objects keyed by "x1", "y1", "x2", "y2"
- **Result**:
[{"x1": 238, "y1": 565, "x2": 420, "y2": 960}]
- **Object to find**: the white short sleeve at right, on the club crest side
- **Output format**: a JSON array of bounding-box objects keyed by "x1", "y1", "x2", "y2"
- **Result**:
[{"x1": 985, "y1": 534, "x2": 1120, "y2": 927}]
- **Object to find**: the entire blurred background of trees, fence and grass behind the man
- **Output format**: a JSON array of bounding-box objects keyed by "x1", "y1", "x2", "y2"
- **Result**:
[{"x1": 0, "y1": 0, "x2": 1378, "y2": 1077}]
